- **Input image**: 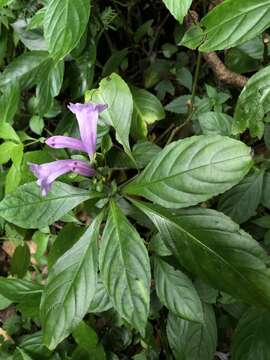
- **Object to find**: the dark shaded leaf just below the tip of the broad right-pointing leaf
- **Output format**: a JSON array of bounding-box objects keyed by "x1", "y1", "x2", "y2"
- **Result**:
[{"x1": 218, "y1": 170, "x2": 264, "y2": 224}]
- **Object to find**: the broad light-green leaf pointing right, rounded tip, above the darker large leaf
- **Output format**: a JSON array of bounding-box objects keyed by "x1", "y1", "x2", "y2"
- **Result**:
[{"x1": 124, "y1": 135, "x2": 252, "y2": 208}]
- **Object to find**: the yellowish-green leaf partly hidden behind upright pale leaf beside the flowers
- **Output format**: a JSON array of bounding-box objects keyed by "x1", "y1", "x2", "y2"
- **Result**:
[{"x1": 131, "y1": 87, "x2": 165, "y2": 139}]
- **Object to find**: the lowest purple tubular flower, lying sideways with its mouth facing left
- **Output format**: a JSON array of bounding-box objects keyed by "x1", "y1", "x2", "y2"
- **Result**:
[{"x1": 29, "y1": 159, "x2": 95, "y2": 196}]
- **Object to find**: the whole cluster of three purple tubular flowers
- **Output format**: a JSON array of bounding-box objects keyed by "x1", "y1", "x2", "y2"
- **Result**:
[{"x1": 29, "y1": 103, "x2": 107, "y2": 196}]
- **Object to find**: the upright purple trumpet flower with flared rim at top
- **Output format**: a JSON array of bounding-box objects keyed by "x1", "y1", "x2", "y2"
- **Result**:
[{"x1": 68, "y1": 103, "x2": 107, "y2": 159}]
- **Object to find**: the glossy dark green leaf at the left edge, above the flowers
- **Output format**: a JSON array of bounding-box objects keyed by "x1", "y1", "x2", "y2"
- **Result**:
[{"x1": 0, "y1": 51, "x2": 51, "y2": 88}]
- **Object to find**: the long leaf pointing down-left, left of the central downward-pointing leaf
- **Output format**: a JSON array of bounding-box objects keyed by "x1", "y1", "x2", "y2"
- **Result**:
[{"x1": 40, "y1": 214, "x2": 102, "y2": 350}]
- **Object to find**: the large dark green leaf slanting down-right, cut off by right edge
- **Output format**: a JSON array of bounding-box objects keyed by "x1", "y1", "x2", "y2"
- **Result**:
[{"x1": 130, "y1": 201, "x2": 270, "y2": 308}]
